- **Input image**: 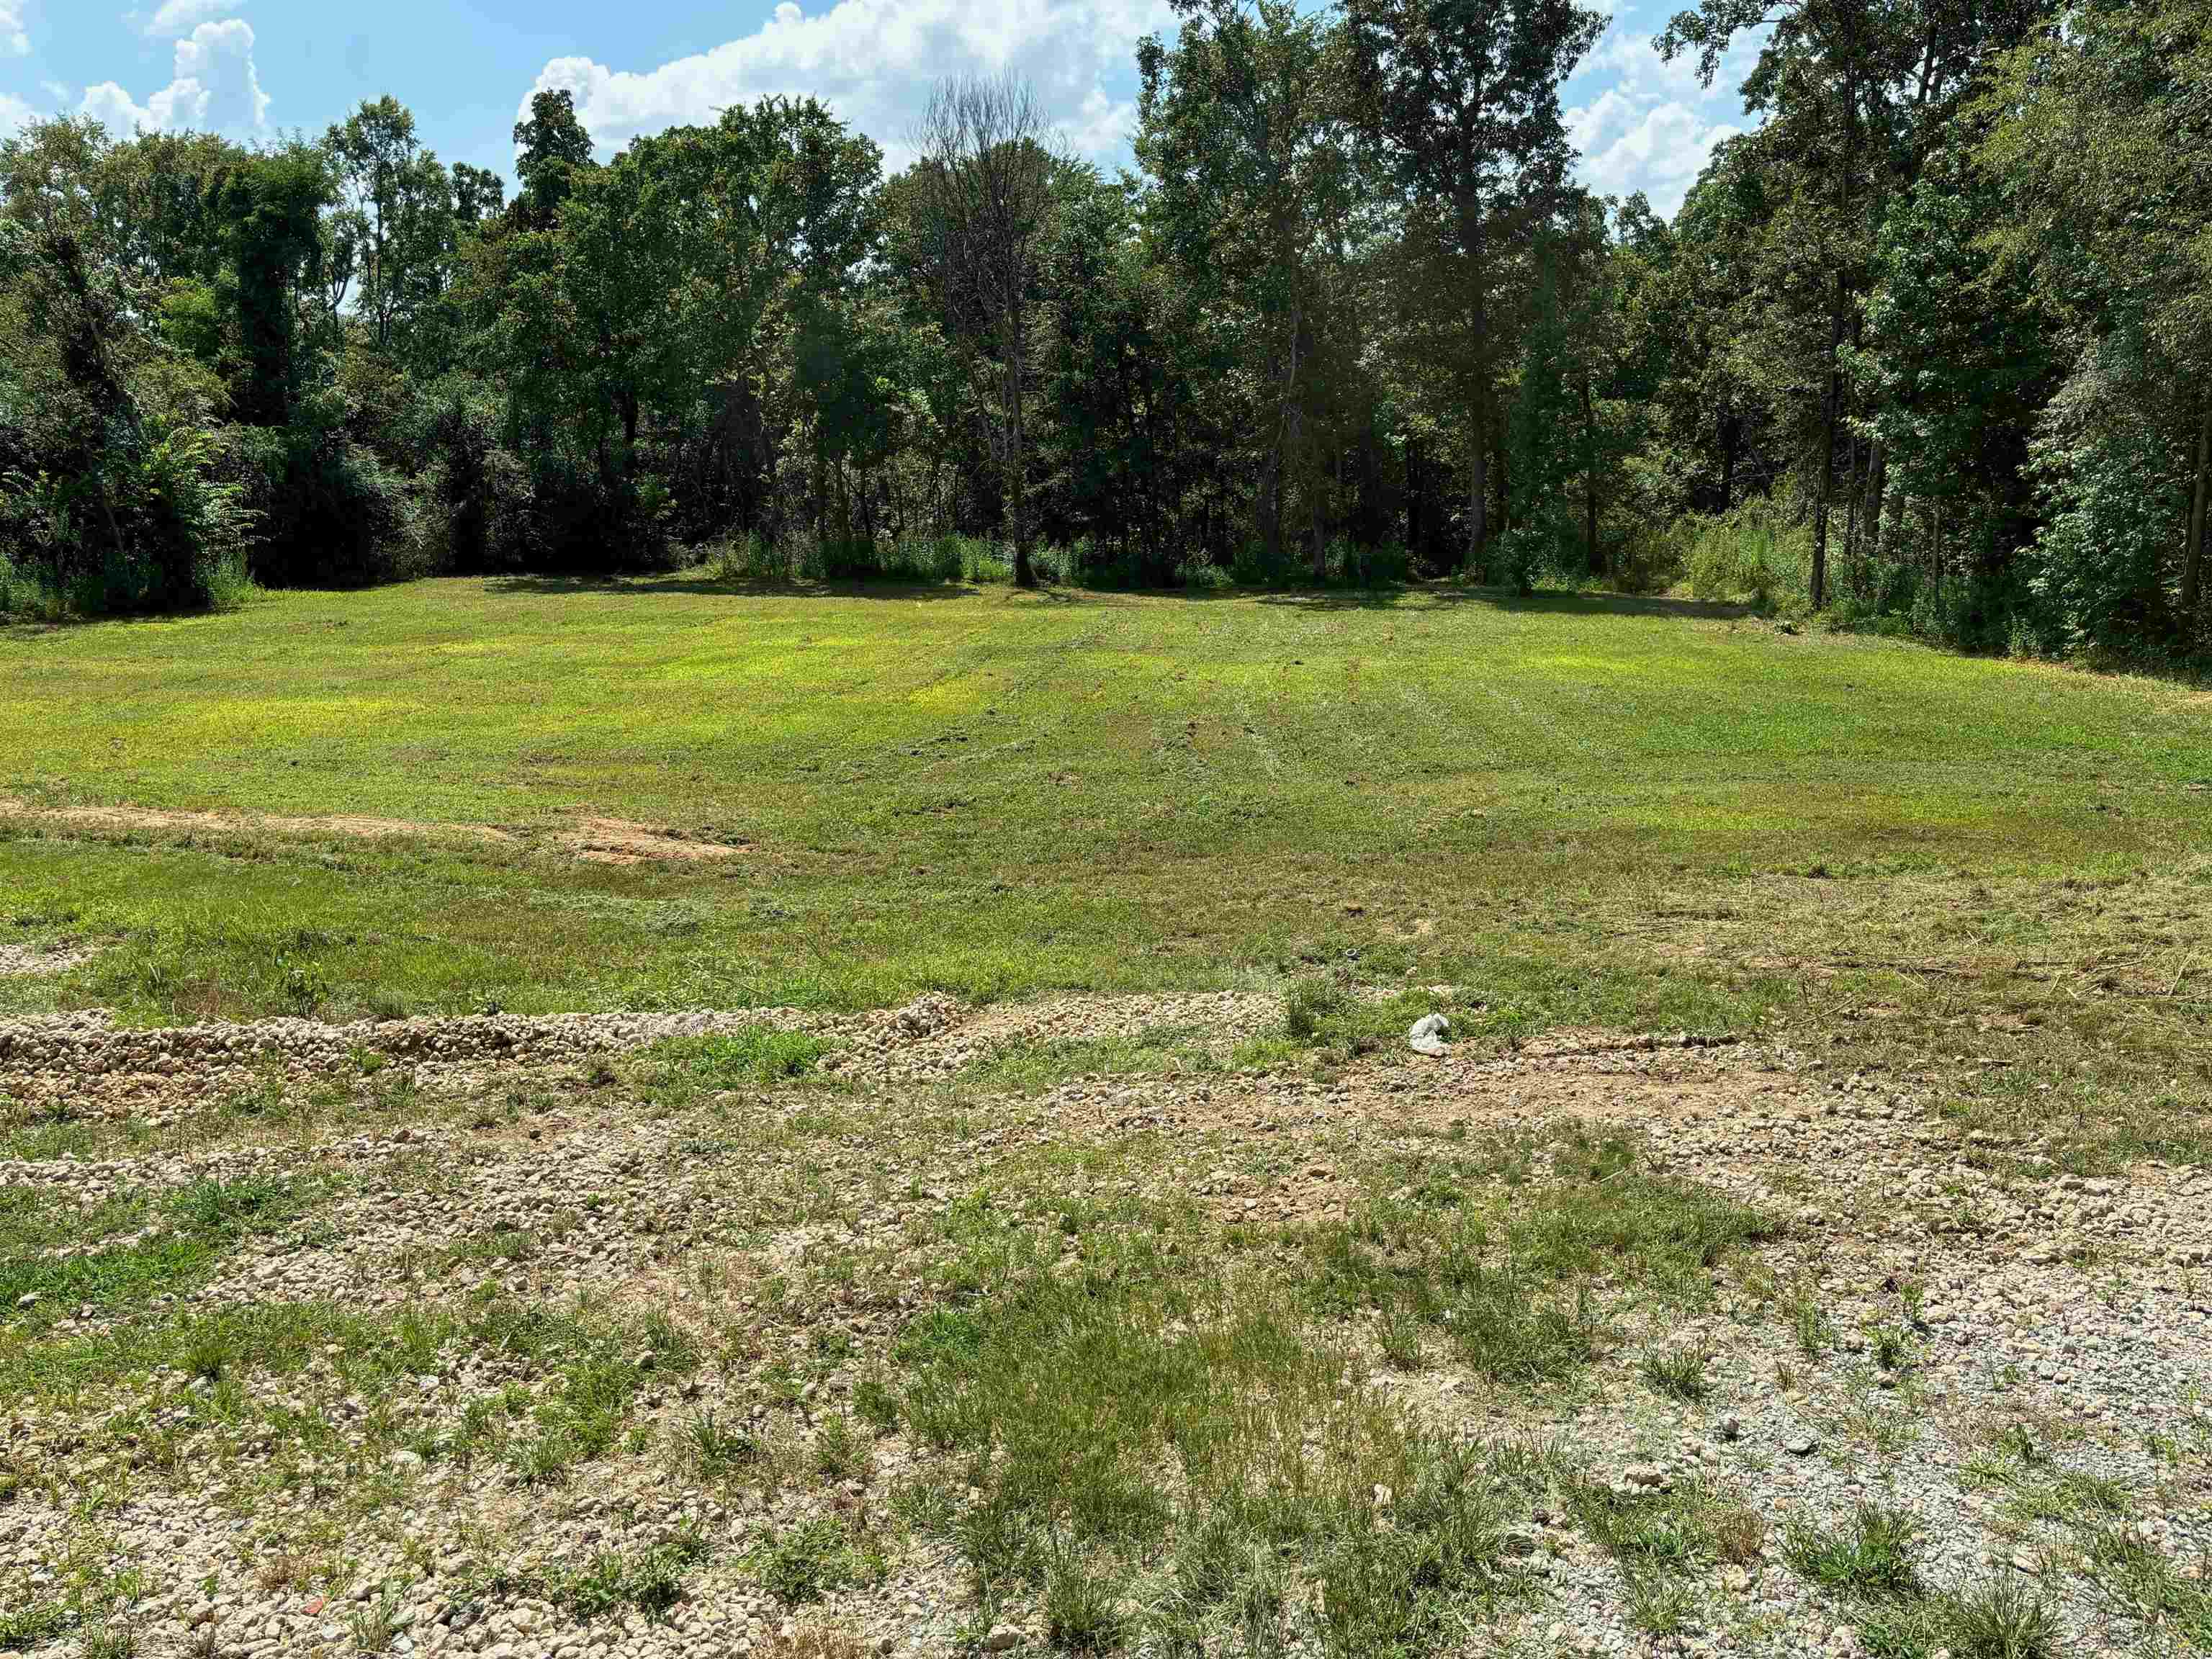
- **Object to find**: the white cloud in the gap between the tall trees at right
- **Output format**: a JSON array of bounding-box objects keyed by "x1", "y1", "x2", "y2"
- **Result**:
[{"x1": 1566, "y1": 24, "x2": 1763, "y2": 215}]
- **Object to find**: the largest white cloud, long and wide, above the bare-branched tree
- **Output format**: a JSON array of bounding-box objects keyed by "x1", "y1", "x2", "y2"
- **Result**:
[{"x1": 522, "y1": 0, "x2": 1174, "y2": 166}]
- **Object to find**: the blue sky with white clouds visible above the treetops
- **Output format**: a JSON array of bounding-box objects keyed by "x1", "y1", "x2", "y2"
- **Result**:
[{"x1": 0, "y1": 0, "x2": 1743, "y2": 212}]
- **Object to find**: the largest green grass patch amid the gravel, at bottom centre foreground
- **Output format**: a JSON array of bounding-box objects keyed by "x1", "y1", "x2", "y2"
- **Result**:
[{"x1": 871, "y1": 1205, "x2": 1511, "y2": 1655}]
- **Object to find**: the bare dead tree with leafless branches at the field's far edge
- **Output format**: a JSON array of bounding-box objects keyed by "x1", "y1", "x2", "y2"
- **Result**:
[{"x1": 914, "y1": 75, "x2": 1057, "y2": 588}]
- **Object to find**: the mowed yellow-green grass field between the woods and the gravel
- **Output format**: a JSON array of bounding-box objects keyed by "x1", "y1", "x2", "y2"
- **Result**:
[{"x1": 0, "y1": 580, "x2": 2212, "y2": 1053}]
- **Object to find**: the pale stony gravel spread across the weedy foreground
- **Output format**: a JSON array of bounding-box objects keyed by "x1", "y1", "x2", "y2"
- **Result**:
[{"x1": 0, "y1": 993, "x2": 2212, "y2": 1659}]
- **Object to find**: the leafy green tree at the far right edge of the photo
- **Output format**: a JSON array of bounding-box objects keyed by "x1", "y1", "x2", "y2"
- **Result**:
[{"x1": 1977, "y1": 0, "x2": 2212, "y2": 644}]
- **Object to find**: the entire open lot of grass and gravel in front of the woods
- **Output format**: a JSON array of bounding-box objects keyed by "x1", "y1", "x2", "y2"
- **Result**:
[{"x1": 0, "y1": 582, "x2": 2212, "y2": 1659}]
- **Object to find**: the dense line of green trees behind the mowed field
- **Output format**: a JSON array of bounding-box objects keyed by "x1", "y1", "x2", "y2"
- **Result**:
[{"x1": 0, "y1": 0, "x2": 2212, "y2": 657}]
